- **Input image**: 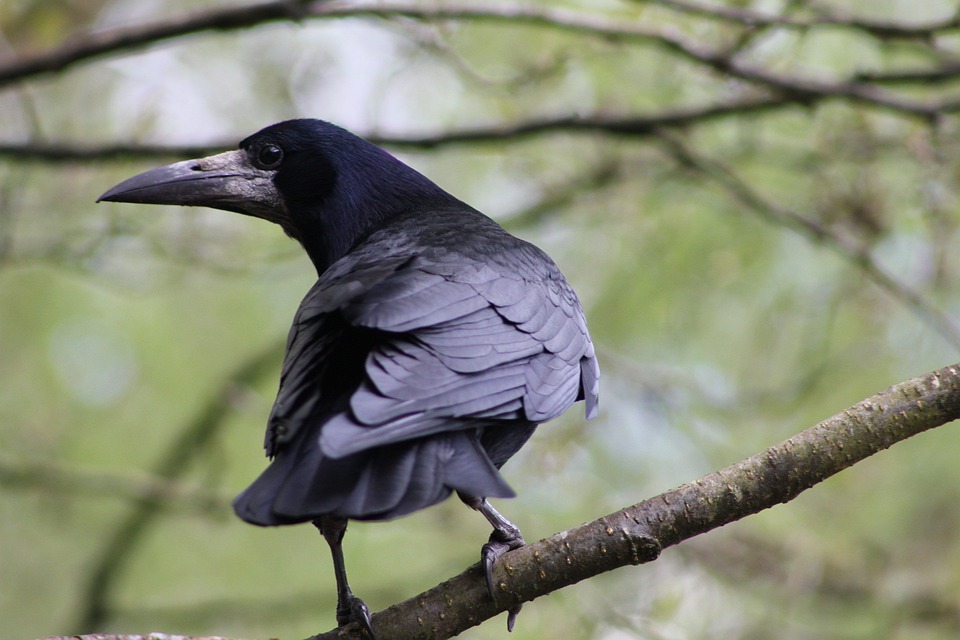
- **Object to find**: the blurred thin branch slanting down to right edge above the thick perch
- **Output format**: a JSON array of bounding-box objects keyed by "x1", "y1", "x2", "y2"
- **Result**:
[{"x1": 660, "y1": 132, "x2": 960, "y2": 349}]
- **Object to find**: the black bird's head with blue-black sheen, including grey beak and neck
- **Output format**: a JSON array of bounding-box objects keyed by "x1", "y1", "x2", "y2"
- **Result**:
[{"x1": 97, "y1": 120, "x2": 454, "y2": 272}]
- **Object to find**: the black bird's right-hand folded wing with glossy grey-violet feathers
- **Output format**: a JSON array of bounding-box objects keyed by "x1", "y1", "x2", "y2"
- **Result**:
[{"x1": 295, "y1": 239, "x2": 597, "y2": 457}]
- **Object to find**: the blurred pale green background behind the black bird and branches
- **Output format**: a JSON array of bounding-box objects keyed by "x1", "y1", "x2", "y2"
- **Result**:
[{"x1": 0, "y1": 0, "x2": 960, "y2": 640}]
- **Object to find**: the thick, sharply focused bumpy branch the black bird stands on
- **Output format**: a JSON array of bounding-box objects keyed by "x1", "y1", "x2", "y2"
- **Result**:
[{"x1": 43, "y1": 364, "x2": 960, "y2": 640}]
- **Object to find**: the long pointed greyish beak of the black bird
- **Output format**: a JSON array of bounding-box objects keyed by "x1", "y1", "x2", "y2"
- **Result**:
[{"x1": 97, "y1": 151, "x2": 286, "y2": 222}]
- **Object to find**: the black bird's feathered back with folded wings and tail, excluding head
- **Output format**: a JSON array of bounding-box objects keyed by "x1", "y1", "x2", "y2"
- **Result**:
[{"x1": 234, "y1": 205, "x2": 598, "y2": 525}]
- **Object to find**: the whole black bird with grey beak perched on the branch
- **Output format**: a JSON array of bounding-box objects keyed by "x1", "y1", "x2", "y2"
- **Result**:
[{"x1": 98, "y1": 120, "x2": 599, "y2": 637}]
